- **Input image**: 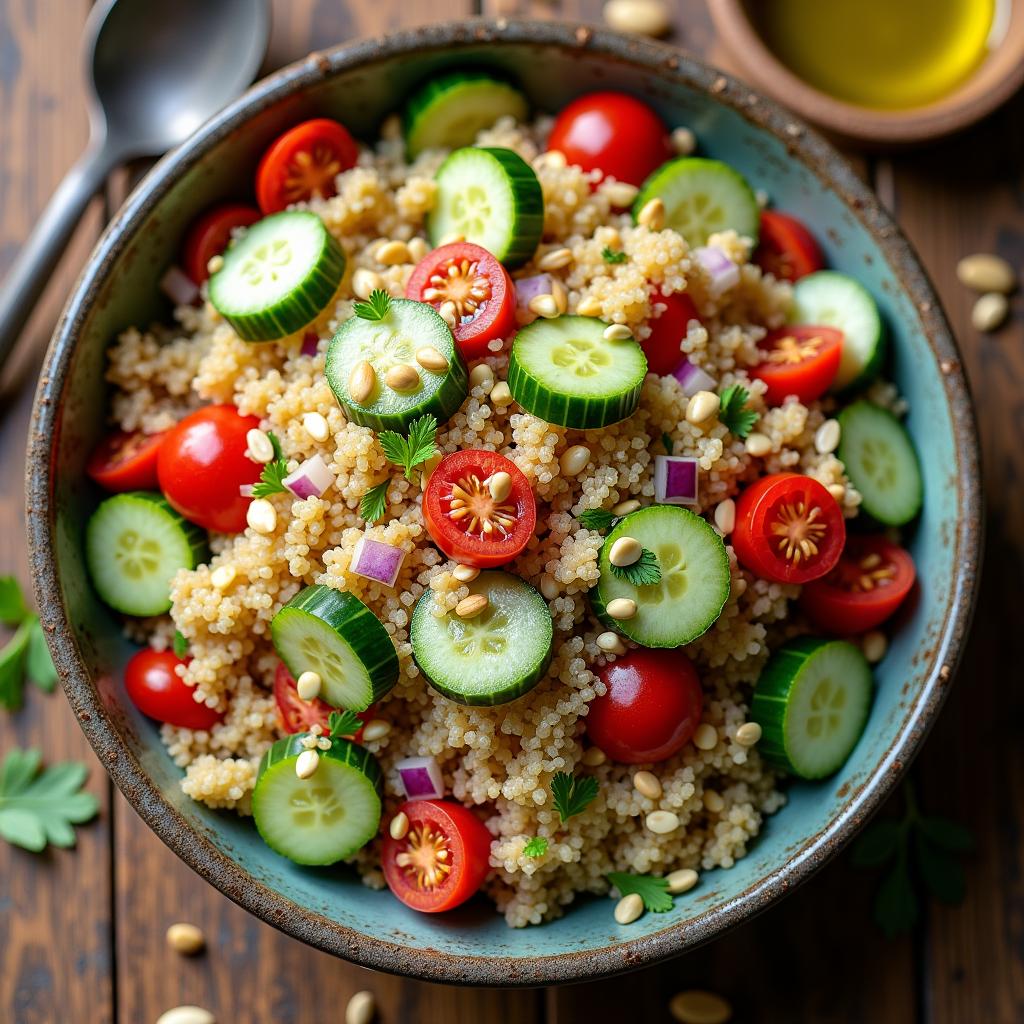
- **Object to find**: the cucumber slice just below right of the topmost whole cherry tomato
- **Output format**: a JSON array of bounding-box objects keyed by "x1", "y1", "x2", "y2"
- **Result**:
[{"x1": 633, "y1": 157, "x2": 761, "y2": 248}]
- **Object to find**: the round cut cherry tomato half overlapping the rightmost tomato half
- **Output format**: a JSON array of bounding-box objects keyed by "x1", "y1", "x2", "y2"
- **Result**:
[{"x1": 732, "y1": 473, "x2": 846, "y2": 583}]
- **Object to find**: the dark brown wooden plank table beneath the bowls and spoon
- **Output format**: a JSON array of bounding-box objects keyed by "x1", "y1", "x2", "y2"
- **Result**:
[{"x1": 0, "y1": 0, "x2": 1024, "y2": 1024}]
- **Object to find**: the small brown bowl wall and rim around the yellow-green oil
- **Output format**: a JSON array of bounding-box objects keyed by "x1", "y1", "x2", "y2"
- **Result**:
[{"x1": 708, "y1": 0, "x2": 1024, "y2": 148}]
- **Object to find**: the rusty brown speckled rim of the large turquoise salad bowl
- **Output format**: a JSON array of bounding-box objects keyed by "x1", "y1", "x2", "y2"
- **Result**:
[{"x1": 26, "y1": 18, "x2": 982, "y2": 987}]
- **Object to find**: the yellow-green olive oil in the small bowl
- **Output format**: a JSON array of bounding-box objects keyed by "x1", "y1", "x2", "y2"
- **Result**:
[{"x1": 749, "y1": 0, "x2": 997, "y2": 110}]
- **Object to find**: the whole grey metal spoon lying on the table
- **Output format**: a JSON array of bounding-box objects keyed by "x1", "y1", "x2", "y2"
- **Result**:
[{"x1": 0, "y1": 0, "x2": 270, "y2": 367}]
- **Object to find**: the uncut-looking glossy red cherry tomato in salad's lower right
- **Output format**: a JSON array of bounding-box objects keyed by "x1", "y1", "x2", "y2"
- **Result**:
[{"x1": 587, "y1": 647, "x2": 701, "y2": 765}]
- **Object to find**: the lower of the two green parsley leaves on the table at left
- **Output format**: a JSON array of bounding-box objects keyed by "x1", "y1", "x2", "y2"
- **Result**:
[{"x1": 0, "y1": 748, "x2": 99, "y2": 853}]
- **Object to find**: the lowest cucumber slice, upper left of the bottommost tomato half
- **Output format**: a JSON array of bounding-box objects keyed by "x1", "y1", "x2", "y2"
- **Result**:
[{"x1": 253, "y1": 733, "x2": 383, "y2": 864}]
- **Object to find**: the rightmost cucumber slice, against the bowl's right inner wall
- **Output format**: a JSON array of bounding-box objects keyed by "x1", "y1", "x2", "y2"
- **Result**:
[{"x1": 836, "y1": 398, "x2": 925, "y2": 526}]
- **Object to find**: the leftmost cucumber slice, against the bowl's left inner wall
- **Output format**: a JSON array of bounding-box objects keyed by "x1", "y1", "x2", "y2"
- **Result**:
[{"x1": 85, "y1": 490, "x2": 210, "y2": 615}]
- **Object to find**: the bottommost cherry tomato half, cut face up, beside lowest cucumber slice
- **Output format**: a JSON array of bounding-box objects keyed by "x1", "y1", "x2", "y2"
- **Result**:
[{"x1": 381, "y1": 800, "x2": 490, "y2": 913}]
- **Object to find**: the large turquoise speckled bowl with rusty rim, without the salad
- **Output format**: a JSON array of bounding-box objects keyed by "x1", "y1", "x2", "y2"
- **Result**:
[{"x1": 28, "y1": 20, "x2": 981, "y2": 986}]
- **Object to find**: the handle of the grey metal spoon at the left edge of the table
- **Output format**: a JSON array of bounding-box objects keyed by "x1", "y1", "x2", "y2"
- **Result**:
[{"x1": 0, "y1": 142, "x2": 117, "y2": 369}]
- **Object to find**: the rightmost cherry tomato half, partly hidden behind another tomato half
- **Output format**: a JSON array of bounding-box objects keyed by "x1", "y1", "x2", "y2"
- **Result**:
[{"x1": 800, "y1": 537, "x2": 915, "y2": 635}]
